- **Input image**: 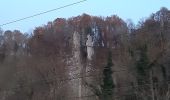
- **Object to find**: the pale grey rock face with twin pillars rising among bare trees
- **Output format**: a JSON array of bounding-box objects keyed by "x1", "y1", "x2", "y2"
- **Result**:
[{"x1": 70, "y1": 32, "x2": 94, "y2": 100}]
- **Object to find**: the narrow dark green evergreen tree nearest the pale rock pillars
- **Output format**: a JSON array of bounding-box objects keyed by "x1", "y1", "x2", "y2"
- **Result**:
[{"x1": 101, "y1": 52, "x2": 114, "y2": 100}]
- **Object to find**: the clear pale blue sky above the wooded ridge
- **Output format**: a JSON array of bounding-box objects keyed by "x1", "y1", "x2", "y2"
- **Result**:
[{"x1": 0, "y1": 0, "x2": 170, "y2": 33}]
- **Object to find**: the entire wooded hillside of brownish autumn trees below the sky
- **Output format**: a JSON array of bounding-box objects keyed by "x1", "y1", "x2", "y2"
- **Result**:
[{"x1": 0, "y1": 7, "x2": 170, "y2": 100}]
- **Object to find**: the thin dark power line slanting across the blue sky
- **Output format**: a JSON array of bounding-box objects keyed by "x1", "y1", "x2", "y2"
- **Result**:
[{"x1": 0, "y1": 0, "x2": 87, "y2": 27}]
